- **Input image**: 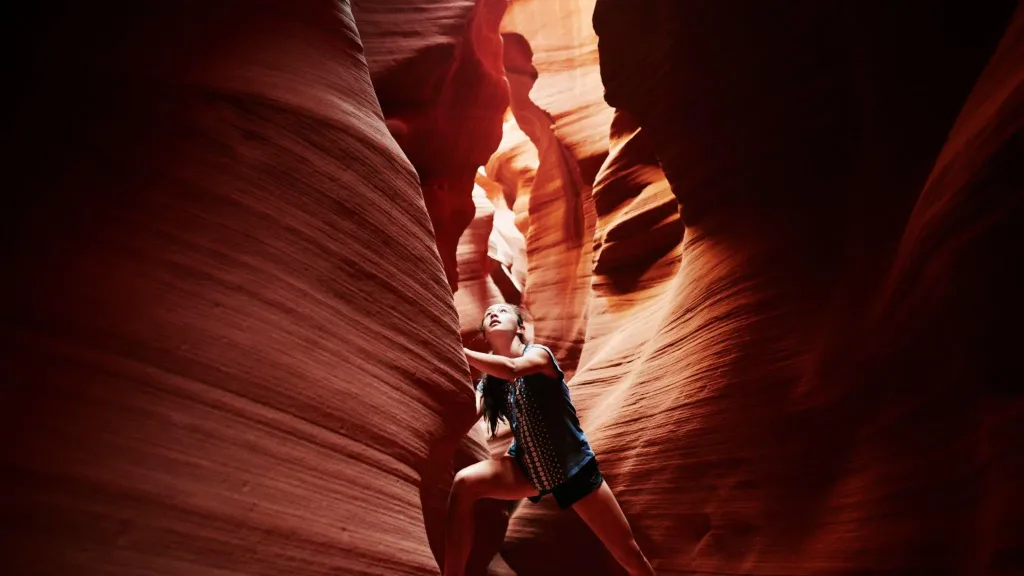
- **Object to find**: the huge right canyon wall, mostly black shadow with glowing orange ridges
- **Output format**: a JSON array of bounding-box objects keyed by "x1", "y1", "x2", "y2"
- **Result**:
[{"x1": 493, "y1": 0, "x2": 1024, "y2": 575}]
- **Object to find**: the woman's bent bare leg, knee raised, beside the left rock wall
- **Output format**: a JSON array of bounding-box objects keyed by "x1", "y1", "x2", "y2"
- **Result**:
[{"x1": 443, "y1": 455, "x2": 537, "y2": 576}]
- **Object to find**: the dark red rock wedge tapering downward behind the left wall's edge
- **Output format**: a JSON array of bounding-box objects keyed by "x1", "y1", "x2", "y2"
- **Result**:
[{"x1": 353, "y1": 0, "x2": 509, "y2": 290}]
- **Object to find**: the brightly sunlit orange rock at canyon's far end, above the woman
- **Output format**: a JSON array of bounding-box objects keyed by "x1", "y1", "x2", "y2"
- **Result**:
[{"x1": 440, "y1": 0, "x2": 612, "y2": 373}]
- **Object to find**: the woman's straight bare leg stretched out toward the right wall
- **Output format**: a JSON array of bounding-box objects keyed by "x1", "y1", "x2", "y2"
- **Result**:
[{"x1": 572, "y1": 482, "x2": 654, "y2": 576}]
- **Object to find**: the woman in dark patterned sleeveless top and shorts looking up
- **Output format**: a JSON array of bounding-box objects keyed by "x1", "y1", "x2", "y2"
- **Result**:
[{"x1": 444, "y1": 304, "x2": 654, "y2": 576}]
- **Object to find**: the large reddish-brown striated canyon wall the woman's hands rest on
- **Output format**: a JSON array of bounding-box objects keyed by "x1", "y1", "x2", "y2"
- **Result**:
[{"x1": 0, "y1": 1, "x2": 475, "y2": 575}]
